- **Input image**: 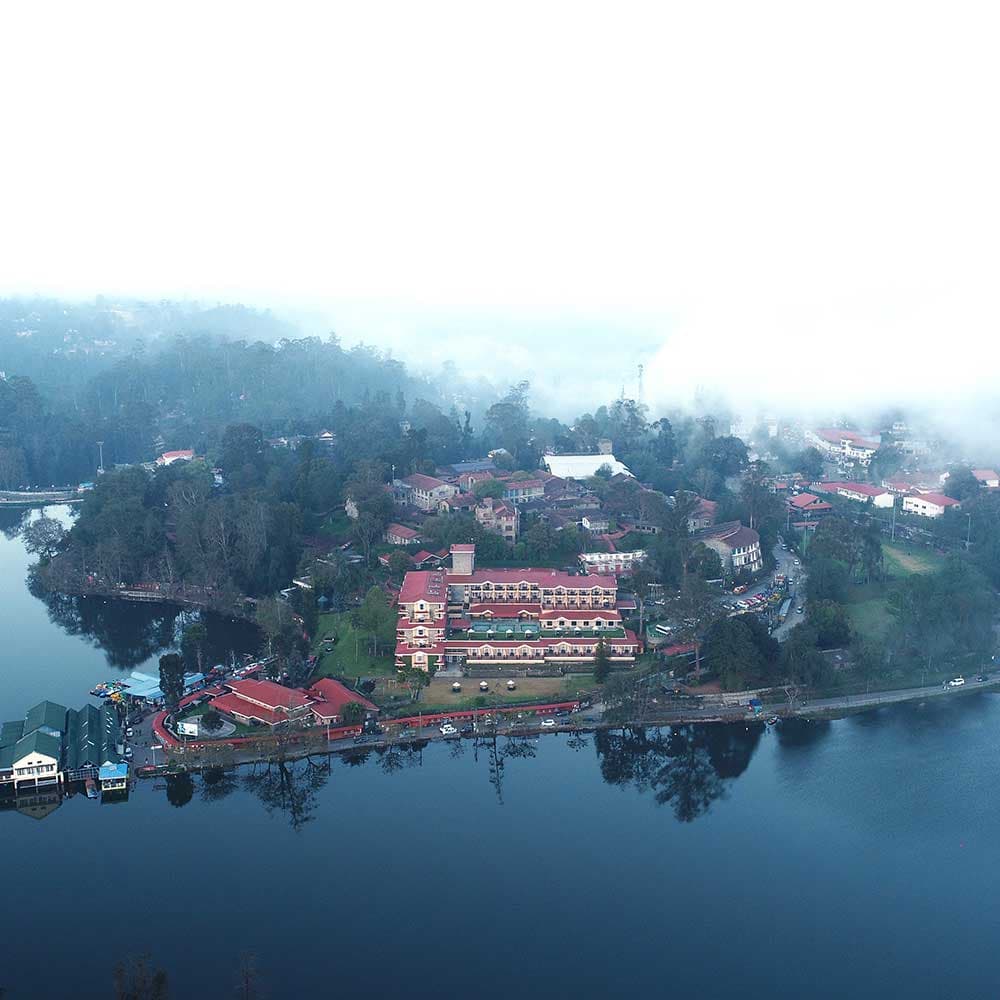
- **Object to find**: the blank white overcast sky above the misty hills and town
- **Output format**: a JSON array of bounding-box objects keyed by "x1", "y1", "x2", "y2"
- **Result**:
[{"x1": 0, "y1": 0, "x2": 1000, "y2": 424}]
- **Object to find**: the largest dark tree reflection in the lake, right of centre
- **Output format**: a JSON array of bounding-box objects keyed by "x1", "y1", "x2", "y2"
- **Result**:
[{"x1": 594, "y1": 724, "x2": 764, "y2": 823}]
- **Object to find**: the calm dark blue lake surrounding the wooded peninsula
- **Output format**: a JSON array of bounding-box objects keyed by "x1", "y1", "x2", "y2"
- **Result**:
[{"x1": 0, "y1": 512, "x2": 1000, "y2": 998}]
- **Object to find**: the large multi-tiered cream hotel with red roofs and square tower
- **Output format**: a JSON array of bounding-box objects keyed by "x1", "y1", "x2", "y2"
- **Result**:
[{"x1": 396, "y1": 545, "x2": 641, "y2": 670}]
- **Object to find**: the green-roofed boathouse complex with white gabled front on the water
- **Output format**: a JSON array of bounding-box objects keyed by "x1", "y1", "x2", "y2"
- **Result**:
[{"x1": 0, "y1": 701, "x2": 128, "y2": 792}]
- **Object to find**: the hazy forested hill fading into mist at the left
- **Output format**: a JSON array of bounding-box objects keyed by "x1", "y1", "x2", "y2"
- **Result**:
[{"x1": 0, "y1": 292, "x2": 460, "y2": 489}]
